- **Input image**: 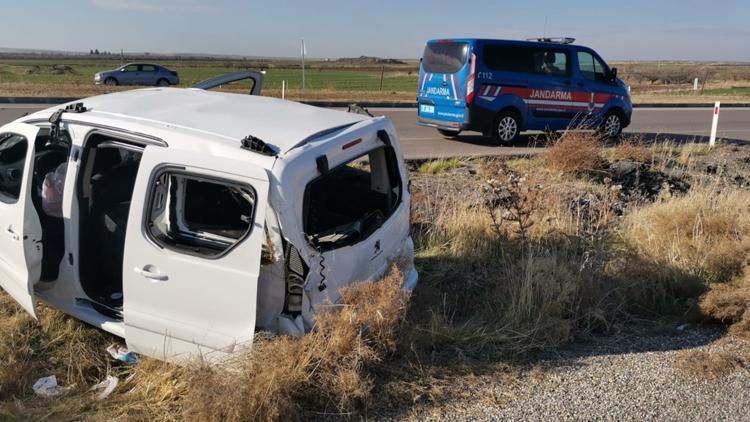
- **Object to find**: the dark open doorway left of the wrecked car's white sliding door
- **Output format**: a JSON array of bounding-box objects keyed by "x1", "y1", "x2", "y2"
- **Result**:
[{"x1": 78, "y1": 134, "x2": 143, "y2": 318}]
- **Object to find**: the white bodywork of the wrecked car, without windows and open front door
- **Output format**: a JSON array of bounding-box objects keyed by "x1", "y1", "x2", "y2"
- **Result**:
[{"x1": 4, "y1": 88, "x2": 418, "y2": 360}]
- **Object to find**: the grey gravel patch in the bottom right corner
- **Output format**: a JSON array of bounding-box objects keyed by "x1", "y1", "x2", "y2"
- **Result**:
[{"x1": 409, "y1": 328, "x2": 750, "y2": 421}]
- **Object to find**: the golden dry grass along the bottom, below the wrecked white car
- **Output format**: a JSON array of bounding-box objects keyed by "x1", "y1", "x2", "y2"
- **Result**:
[{"x1": 0, "y1": 267, "x2": 407, "y2": 421}]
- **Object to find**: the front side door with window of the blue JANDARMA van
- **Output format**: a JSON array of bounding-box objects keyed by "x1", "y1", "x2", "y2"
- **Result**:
[{"x1": 576, "y1": 50, "x2": 613, "y2": 121}]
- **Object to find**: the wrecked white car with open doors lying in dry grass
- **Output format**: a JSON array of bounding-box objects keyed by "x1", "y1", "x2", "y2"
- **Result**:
[{"x1": 0, "y1": 88, "x2": 417, "y2": 359}]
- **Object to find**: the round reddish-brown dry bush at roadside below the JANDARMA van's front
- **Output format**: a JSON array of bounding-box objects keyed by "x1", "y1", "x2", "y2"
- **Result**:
[{"x1": 545, "y1": 131, "x2": 602, "y2": 173}]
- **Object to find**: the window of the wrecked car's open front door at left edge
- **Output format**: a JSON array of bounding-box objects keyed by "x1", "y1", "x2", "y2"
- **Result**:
[{"x1": 0, "y1": 133, "x2": 29, "y2": 204}]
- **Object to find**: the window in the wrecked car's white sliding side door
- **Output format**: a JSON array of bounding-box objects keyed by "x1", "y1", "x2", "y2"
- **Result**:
[{"x1": 146, "y1": 169, "x2": 256, "y2": 258}]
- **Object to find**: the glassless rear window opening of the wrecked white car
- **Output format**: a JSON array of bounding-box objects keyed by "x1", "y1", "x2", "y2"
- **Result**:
[{"x1": 304, "y1": 147, "x2": 401, "y2": 250}]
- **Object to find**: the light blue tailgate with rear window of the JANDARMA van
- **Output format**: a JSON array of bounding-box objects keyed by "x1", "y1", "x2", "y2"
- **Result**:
[{"x1": 418, "y1": 42, "x2": 470, "y2": 130}]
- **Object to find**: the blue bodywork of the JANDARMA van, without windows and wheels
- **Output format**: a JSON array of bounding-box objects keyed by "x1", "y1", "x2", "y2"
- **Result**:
[{"x1": 417, "y1": 38, "x2": 632, "y2": 133}]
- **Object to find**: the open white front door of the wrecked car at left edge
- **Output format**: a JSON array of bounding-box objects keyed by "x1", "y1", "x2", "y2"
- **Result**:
[{"x1": 0, "y1": 123, "x2": 42, "y2": 317}]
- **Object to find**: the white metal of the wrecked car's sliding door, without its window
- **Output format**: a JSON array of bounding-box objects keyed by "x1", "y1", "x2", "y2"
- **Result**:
[{"x1": 123, "y1": 144, "x2": 268, "y2": 359}]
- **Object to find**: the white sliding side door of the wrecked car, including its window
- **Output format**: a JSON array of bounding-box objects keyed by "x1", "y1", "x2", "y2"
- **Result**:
[{"x1": 123, "y1": 146, "x2": 268, "y2": 359}]
